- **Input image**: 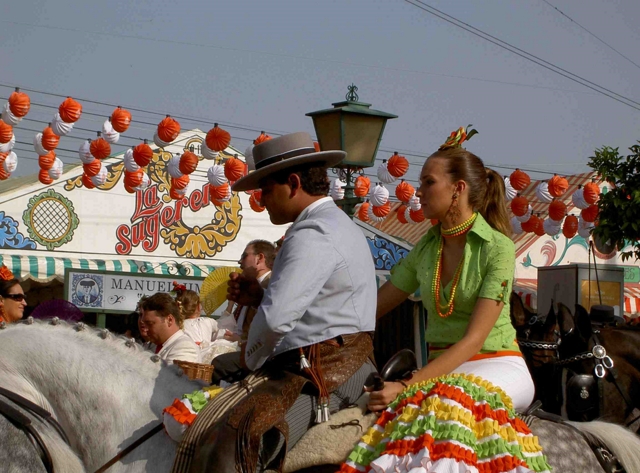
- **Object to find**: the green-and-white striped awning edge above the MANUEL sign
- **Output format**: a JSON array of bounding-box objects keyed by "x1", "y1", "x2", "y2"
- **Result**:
[{"x1": 0, "y1": 253, "x2": 216, "y2": 283}]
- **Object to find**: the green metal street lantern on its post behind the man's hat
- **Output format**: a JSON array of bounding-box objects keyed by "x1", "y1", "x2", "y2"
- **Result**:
[{"x1": 307, "y1": 84, "x2": 398, "y2": 218}]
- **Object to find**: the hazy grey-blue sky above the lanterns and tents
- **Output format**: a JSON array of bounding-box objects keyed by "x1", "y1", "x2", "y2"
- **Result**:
[{"x1": 0, "y1": 0, "x2": 640, "y2": 190}]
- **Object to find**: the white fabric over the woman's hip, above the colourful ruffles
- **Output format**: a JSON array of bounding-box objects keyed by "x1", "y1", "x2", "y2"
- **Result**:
[{"x1": 453, "y1": 356, "x2": 535, "y2": 412}]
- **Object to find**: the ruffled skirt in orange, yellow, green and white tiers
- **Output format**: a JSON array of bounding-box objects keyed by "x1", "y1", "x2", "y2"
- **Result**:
[{"x1": 340, "y1": 374, "x2": 551, "y2": 473}]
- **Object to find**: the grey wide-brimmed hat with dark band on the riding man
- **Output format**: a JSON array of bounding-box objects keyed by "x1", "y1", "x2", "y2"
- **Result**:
[{"x1": 231, "y1": 131, "x2": 347, "y2": 191}]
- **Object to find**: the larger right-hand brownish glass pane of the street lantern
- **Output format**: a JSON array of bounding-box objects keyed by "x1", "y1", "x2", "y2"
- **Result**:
[{"x1": 343, "y1": 114, "x2": 386, "y2": 167}]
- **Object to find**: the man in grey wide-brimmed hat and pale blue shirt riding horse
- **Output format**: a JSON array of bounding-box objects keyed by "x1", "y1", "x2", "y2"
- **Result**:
[{"x1": 191, "y1": 133, "x2": 376, "y2": 472}]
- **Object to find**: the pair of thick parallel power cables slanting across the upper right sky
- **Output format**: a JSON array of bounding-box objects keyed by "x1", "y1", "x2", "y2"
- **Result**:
[{"x1": 403, "y1": 0, "x2": 640, "y2": 111}]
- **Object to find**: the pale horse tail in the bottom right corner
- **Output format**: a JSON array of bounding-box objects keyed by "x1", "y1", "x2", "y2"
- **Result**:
[{"x1": 567, "y1": 421, "x2": 640, "y2": 472}]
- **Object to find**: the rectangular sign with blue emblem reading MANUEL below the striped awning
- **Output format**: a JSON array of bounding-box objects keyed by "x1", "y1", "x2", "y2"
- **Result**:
[{"x1": 64, "y1": 269, "x2": 203, "y2": 314}]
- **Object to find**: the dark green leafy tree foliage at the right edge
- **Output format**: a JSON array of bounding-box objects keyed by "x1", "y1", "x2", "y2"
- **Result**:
[{"x1": 589, "y1": 142, "x2": 640, "y2": 261}]
